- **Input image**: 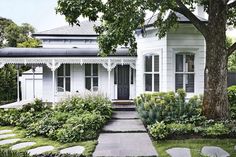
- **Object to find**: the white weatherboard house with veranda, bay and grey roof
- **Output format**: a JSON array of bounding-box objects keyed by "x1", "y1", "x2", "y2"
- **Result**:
[{"x1": 0, "y1": 14, "x2": 206, "y2": 102}]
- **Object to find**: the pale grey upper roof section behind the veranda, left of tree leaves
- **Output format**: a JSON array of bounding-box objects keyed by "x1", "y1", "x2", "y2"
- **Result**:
[{"x1": 33, "y1": 21, "x2": 100, "y2": 36}]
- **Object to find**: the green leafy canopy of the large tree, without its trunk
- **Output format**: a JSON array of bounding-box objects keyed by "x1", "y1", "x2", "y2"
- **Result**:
[{"x1": 56, "y1": 0, "x2": 236, "y2": 54}]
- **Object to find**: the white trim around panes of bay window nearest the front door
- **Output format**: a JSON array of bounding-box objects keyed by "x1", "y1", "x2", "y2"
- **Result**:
[{"x1": 144, "y1": 53, "x2": 161, "y2": 92}]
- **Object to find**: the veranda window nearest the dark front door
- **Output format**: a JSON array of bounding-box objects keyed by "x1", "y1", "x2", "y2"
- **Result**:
[{"x1": 85, "y1": 64, "x2": 98, "y2": 91}]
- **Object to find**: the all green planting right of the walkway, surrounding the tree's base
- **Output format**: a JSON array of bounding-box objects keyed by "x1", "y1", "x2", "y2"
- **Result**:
[{"x1": 135, "y1": 87, "x2": 236, "y2": 139}]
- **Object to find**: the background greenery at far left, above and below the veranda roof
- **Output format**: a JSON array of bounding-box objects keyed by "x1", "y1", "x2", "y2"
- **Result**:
[{"x1": 0, "y1": 18, "x2": 40, "y2": 103}]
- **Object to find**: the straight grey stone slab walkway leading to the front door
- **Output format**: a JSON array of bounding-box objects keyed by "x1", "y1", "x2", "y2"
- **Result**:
[{"x1": 93, "y1": 105, "x2": 158, "y2": 157}]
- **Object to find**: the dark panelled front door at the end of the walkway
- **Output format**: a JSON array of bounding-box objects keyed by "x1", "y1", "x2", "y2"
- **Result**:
[{"x1": 118, "y1": 65, "x2": 129, "y2": 100}]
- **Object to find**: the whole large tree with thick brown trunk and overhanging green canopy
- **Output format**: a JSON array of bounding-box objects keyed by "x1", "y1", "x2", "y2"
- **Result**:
[{"x1": 56, "y1": 0, "x2": 236, "y2": 119}]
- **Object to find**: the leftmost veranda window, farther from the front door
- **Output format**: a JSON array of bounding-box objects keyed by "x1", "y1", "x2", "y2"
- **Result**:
[{"x1": 57, "y1": 64, "x2": 70, "y2": 92}]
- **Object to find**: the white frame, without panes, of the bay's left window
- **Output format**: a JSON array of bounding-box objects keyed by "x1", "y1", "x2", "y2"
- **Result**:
[{"x1": 144, "y1": 54, "x2": 160, "y2": 92}]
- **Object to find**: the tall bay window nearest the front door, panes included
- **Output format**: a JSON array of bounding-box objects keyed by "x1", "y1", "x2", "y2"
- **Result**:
[{"x1": 144, "y1": 55, "x2": 160, "y2": 92}]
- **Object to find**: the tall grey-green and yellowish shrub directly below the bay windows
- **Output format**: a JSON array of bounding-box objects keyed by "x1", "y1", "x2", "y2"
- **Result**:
[{"x1": 135, "y1": 90, "x2": 204, "y2": 124}]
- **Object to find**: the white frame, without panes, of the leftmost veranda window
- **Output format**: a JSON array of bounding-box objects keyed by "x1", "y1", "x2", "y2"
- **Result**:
[{"x1": 57, "y1": 64, "x2": 71, "y2": 93}]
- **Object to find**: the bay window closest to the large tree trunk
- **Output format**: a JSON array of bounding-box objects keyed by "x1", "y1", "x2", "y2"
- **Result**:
[{"x1": 175, "y1": 54, "x2": 194, "y2": 93}]
